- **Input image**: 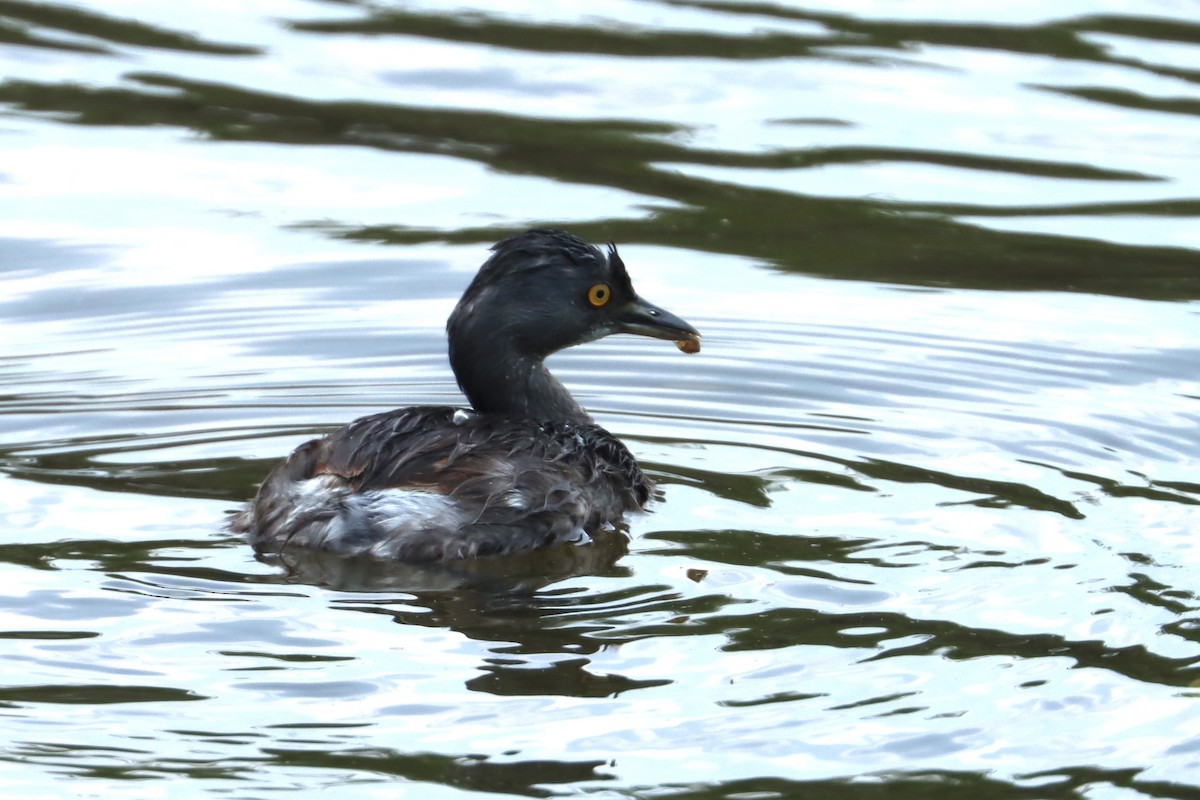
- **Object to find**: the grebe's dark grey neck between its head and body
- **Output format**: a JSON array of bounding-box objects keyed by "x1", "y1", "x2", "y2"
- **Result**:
[{"x1": 450, "y1": 341, "x2": 592, "y2": 423}]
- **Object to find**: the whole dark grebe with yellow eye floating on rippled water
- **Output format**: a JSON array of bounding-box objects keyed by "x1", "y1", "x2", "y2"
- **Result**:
[{"x1": 233, "y1": 229, "x2": 700, "y2": 563}]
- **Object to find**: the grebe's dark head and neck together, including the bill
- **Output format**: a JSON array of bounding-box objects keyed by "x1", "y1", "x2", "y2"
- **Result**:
[{"x1": 446, "y1": 229, "x2": 700, "y2": 421}]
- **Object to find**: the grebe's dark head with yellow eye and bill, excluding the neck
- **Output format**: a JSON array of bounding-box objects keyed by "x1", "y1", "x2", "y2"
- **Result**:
[{"x1": 446, "y1": 229, "x2": 700, "y2": 357}]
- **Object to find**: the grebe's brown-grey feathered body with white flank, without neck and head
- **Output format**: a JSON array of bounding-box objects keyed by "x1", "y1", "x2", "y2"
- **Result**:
[{"x1": 234, "y1": 407, "x2": 653, "y2": 563}]
